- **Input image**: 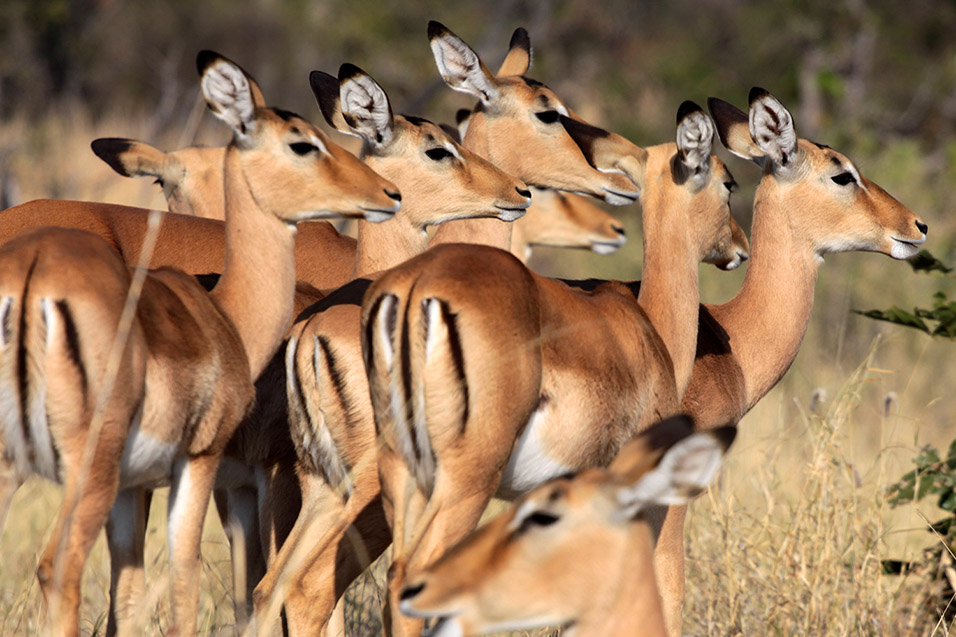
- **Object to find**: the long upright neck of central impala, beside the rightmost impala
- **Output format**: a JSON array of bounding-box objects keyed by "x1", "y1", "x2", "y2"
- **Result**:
[{"x1": 637, "y1": 188, "x2": 700, "y2": 396}]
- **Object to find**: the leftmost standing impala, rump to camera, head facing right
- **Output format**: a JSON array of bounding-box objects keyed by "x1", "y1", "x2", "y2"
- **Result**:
[{"x1": 0, "y1": 51, "x2": 398, "y2": 634}]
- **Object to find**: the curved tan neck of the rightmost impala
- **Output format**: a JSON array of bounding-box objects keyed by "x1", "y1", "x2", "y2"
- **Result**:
[{"x1": 711, "y1": 177, "x2": 820, "y2": 411}]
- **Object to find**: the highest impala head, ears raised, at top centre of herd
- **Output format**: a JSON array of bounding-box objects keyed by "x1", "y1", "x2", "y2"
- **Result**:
[{"x1": 428, "y1": 21, "x2": 638, "y2": 205}]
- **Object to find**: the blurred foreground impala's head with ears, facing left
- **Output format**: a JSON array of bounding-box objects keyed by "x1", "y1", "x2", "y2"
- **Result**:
[{"x1": 401, "y1": 417, "x2": 735, "y2": 636}]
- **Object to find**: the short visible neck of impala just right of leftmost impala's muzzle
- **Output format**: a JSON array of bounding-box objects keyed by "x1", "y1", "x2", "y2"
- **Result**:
[{"x1": 352, "y1": 214, "x2": 428, "y2": 278}]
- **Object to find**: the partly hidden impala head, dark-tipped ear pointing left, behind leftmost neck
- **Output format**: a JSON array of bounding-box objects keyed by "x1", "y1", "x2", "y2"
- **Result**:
[{"x1": 91, "y1": 137, "x2": 226, "y2": 219}]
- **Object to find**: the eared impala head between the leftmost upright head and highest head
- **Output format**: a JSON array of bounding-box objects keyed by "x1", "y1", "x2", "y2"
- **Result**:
[{"x1": 309, "y1": 64, "x2": 531, "y2": 229}]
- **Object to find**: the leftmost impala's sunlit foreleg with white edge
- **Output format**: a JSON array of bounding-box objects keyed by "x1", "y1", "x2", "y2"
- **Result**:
[{"x1": 168, "y1": 455, "x2": 220, "y2": 635}]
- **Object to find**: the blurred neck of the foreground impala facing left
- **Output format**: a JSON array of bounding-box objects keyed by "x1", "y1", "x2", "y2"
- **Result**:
[{"x1": 564, "y1": 523, "x2": 667, "y2": 637}]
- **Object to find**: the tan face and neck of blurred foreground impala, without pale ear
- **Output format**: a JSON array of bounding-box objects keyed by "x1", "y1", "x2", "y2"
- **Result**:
[{"x1": 402, "y1": 419, "x2": 729, "y2": 637}]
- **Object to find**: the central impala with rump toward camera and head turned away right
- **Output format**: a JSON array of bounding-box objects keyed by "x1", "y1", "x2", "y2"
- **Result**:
[{"x1": 363, "y1": 102, "x2": 747, "y2": 631}]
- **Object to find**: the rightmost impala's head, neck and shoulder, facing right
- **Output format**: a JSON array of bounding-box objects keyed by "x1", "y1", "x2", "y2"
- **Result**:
[{"x1": 682, "y1": 87, "x2": 928, "y2": 429}]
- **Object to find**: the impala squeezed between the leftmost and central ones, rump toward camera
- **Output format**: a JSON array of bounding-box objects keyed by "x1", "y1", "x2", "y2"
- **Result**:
[{"x1": 256, "y1": 70, "x2": 530, "y2": 634}]
